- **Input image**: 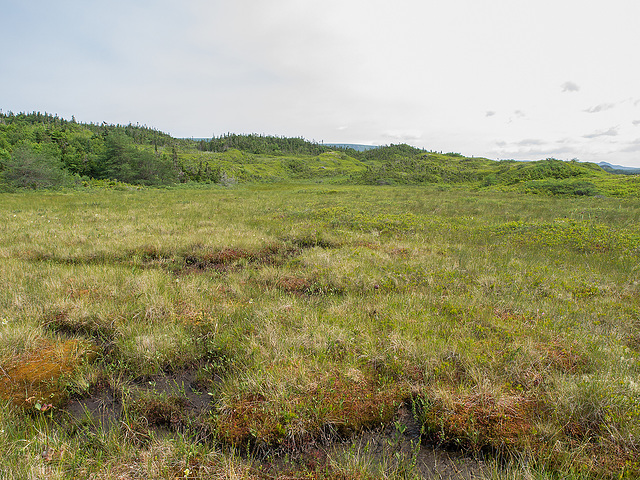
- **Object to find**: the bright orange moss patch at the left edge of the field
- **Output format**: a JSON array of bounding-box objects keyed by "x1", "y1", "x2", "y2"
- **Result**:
[{"x1": 0, "y1": 339, "x2": 95, "y2": 409}]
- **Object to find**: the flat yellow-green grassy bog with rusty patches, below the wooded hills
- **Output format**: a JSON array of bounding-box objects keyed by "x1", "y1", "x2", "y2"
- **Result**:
[{"x1": 0, "y1": 184, "x2": 640, "y2": 479}]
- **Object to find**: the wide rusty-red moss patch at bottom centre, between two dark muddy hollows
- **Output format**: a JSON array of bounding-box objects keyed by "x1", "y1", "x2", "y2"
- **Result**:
[{"x1": 216, "y1": 372, "x2": 405, "y2": 445}]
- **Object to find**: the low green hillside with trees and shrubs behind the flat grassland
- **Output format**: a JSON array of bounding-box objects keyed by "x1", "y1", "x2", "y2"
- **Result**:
[{"x1": 0, "y1": 112, "x2": 640, "y2": 196}]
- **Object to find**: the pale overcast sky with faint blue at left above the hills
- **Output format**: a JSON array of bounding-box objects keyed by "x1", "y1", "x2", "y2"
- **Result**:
[{"x1": 0, "y1": 0, "x2": 640, "y2": 167}]
